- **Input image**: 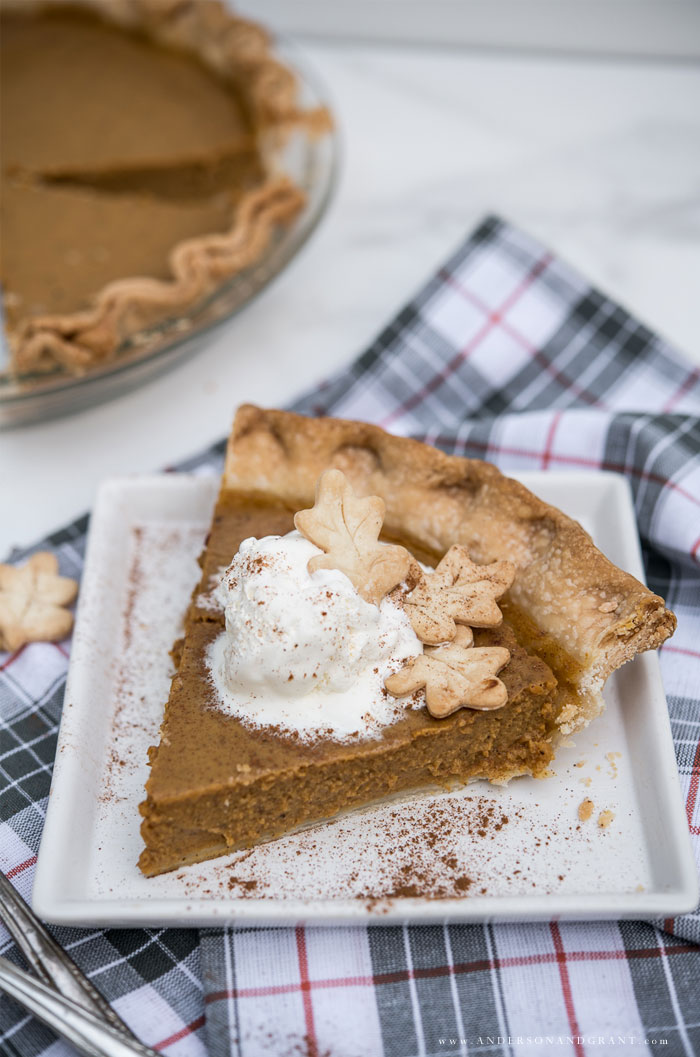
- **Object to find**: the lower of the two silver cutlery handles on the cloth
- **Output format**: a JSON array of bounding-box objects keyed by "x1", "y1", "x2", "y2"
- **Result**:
[{"x1": 0, "y1": 958, "x2": 160, "y2": 1057}]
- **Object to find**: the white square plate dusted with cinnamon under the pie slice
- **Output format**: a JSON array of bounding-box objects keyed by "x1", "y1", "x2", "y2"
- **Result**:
[{"x1": 34, "y1": 474, "x2": 698, "y2": 926}]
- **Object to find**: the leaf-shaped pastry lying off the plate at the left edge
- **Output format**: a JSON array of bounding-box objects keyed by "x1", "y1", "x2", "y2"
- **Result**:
[{"x1": 0, "y1": 551, "x2": 78, "y2": 650}]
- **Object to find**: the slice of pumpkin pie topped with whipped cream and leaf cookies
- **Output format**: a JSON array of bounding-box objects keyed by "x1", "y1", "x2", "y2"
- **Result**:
[{"x1": 134, "y1": 406, "x2": 676, "y2": 875}]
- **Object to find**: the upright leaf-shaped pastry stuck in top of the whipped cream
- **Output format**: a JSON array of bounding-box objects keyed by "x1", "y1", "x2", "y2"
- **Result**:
[{"x1": 294, "y1": 469, "x2": 411, "y2": 604}]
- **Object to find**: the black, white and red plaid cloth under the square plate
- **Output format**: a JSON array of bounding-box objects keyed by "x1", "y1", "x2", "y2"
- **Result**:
[{"x1": 0, "y1": 219, "x2": 700, "y2": 1057}]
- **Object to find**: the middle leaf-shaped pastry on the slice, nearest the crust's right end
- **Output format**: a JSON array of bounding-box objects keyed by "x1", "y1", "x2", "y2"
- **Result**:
[{"x1": 403, "y1": 544, "x2": 515, "y2": 644}]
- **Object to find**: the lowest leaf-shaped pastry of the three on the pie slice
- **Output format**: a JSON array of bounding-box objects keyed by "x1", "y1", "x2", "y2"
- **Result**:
[{"x1": 384, "y1": 627, "x2": 511, "y2": 719}]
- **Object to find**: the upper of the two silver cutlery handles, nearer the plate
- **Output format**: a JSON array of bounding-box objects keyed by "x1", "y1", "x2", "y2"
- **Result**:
[{"x1": 0, "y1": 871, "x2": 139, "y2": 1042}]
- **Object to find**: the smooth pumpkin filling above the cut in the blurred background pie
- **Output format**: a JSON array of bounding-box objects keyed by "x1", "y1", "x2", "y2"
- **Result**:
[{"x1": 1, "y1": 3, "x2": 256, "y2": 180}]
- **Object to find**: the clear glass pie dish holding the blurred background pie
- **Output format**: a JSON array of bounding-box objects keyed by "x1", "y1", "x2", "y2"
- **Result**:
[{"x1": 0, "y1": 39, "x2": 338, "y2": 428}]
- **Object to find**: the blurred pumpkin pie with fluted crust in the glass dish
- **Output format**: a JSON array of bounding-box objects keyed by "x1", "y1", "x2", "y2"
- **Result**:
[{"x1": 0, "y1": 0, "x2": 319, "y2": 372}]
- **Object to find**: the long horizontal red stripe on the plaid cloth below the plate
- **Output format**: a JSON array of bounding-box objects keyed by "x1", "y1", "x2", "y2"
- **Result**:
[{"x1": 204, "y1": 944, "x2": 694, "y2": 1005}]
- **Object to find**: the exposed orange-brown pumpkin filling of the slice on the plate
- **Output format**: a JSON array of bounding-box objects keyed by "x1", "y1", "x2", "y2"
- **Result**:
[{"x1": 140, "y1": 520, "x2": 561, "y2": 875}]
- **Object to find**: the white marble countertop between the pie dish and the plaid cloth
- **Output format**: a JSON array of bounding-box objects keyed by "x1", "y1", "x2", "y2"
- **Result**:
[{"x1": 0, "y1": 42, "x2": 700, "y2": 554}]
